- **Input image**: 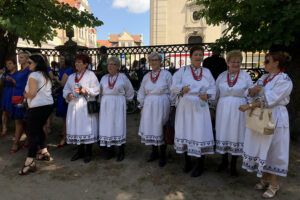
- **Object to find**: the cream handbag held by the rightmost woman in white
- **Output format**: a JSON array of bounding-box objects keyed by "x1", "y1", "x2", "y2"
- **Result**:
[{"x1": 246, "y1": 91, "x2": 275, "y2": 135}]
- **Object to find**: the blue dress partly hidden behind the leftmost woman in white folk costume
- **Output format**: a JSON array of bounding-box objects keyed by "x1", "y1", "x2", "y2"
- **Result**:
[{"x1": 56, "y1": 67, "x2": 73, "y2": 118}]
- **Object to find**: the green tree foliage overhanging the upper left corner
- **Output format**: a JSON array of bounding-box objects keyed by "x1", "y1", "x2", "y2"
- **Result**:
[{"x1": 0, "y1": 0, "x2": 103, "y2": 63}]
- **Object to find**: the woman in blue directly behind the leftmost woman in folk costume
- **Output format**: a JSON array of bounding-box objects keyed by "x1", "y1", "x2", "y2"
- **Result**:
[{"x1": 54, "y1": 56, "x2": 73, "y2": 147}]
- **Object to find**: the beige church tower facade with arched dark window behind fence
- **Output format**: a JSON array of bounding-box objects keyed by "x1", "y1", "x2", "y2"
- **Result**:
[{"x1": 150, "y1": 0, "x2": 225, "y2": 45}]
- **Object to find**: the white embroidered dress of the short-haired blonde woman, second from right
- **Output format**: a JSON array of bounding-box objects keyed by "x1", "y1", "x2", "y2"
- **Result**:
[{"x1": 216, "y1": 71, "x2": 253, "y2": 155}]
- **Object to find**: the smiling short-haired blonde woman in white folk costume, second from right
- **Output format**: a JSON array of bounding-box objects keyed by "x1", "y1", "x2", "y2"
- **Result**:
[{"x1": 216, "y1": 50, "x2": 253, "y2": 176}]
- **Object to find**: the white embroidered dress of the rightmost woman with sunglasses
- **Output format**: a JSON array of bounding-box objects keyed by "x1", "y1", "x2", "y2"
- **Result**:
[{"x1": 242, "y1": 73, "x2": 293, "y2": 177}]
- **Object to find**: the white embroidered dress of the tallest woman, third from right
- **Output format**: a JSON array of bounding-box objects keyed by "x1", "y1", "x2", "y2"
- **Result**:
[{"x1": 171, "y1": 66, "x2": 216, "y2": 157}]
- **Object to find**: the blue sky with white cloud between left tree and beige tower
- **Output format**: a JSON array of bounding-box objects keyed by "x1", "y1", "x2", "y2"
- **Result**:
[{"x1": 89, "y1": 0, "x2": 150, "y2": 45}]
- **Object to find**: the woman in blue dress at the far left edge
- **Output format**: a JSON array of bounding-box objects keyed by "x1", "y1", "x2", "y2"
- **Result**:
[{"x1": 1, "y1": 58, "x2": 17, "y2": 136}]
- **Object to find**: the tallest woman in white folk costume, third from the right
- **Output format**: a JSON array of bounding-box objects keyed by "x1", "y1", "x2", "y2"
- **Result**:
[{"x1": 171, "y1": 46, "x2": 216, "y2": 177}]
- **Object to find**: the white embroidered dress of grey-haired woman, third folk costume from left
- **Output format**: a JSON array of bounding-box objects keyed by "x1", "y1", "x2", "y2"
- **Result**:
[{"x1": 137, "y1": 70, "x2": 172, "y2": 146}]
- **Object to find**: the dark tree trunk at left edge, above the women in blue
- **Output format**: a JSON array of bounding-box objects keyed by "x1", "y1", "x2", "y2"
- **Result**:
[{"x1": 0, "y1": 29, "x2": 19, "y2": 68}]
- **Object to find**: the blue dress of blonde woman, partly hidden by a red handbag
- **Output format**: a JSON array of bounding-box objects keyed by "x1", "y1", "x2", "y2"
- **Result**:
[{"x1": 12, "y1": 68, "x2": 31, "y2": 120}]
